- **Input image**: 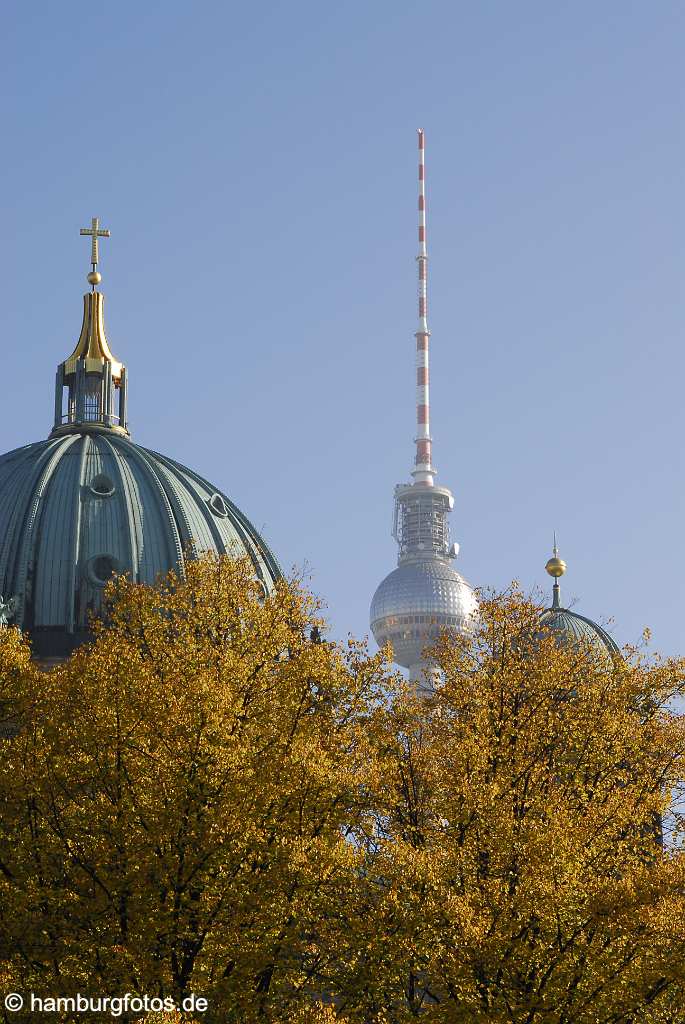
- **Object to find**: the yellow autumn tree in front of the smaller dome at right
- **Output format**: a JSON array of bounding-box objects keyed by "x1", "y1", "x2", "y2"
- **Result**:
[{"x1": 349, "y1": 592, "x2": 685, "y2": 1024}]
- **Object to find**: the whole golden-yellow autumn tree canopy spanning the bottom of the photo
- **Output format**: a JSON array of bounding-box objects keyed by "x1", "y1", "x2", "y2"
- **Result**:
[{"x1": 0, "y1": 558, "x2": 685, "y2": 1024}]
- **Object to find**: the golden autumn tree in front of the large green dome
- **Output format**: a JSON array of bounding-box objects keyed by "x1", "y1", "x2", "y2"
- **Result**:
[{"x1": 0, "y1": 558, "x2": 384, "y2": 1022}]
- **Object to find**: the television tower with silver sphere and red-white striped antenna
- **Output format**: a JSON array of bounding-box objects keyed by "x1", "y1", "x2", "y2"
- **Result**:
[{"x1": 371, "y1": 131, "x2": 477, "y2": 690}]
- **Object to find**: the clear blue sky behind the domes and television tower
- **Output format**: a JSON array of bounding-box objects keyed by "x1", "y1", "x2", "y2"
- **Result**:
[{"x1": 5, "y1": 0, "x2": 685, "y2": 653}]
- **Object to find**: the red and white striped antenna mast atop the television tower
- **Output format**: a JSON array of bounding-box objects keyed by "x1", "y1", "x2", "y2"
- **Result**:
[{"x1": 412, "y1": 128, "x2": 435, "y2": 487}]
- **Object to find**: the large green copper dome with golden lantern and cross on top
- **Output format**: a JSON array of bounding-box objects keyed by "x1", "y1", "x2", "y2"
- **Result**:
[{"x1": 0, "y1": 222, "x2": 281, "y2": 658}]
